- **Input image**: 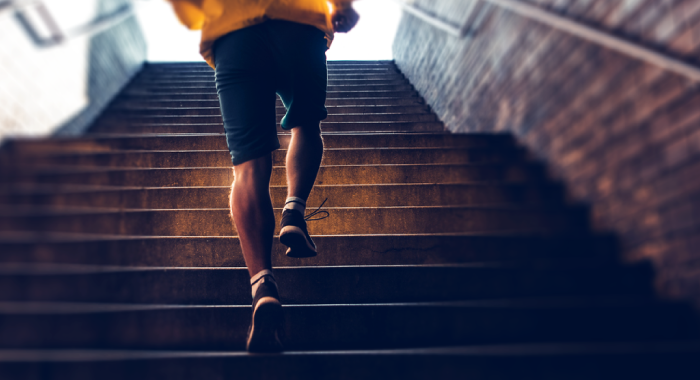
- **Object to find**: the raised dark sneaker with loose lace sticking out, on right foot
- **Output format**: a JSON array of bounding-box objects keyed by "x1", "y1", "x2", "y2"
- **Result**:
[{"x1": 280, "y1": 199, "x2": 328, "y2": 258}]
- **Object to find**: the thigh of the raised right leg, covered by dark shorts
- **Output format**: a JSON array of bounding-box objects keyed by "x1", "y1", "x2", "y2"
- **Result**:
[{"x1": 271, "y1": 21, "x2": 328, "y2": 129}]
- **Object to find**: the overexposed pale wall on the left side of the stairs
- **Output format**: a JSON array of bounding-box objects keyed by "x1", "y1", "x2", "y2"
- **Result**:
[{"x1": 0, "y1": 0, "x2": 146, "y2": 140}]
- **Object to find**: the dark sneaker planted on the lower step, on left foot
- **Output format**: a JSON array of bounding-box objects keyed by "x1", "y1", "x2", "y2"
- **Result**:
[{"x1": 246, "y1": 277, "x2": 282, "y2": 353}]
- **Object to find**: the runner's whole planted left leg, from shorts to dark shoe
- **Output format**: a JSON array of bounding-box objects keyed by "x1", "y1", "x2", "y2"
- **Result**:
[{"x1": 214, "y1": 26, "x2": 282, "y2": 352}]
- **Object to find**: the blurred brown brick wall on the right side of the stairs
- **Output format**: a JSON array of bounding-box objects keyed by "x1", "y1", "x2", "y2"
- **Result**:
[{"x1": 394, "y1": 0, "x2": 700, "y2": 302}]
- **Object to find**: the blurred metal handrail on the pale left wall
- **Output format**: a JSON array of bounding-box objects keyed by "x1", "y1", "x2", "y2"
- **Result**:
[{"x1": 8, "y1": 0, "x2": 134, "y2": 47}]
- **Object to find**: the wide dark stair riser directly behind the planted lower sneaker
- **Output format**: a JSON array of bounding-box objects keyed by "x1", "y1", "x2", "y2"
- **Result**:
[{"x1": 0, "y1": 297, "x2": 697, "y2": 350}]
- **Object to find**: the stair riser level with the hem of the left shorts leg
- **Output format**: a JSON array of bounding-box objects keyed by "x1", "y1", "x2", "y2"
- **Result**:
[{"x1": 10, "y1": 148, "x2": 523, "y2": 170}]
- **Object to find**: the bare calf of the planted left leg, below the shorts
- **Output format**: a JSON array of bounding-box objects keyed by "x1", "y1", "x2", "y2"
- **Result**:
[{"x1": 230, "y1": 154, "x2": 275, "y2": 277}]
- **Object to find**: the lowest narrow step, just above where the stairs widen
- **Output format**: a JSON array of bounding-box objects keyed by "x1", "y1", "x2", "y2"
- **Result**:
[{"x1": 89, "y1": 121, "x2": 445, "y2": 134}]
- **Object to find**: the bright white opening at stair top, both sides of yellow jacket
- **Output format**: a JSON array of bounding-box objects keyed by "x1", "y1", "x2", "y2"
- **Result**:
[{"x1": 136, "y1": 0, "x2": 401, "y2": 61}]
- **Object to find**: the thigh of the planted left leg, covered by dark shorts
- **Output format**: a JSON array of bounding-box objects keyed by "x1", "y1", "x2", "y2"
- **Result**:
[{"x1": 214, "y1": 26, "x2": 280, "y2": 165}]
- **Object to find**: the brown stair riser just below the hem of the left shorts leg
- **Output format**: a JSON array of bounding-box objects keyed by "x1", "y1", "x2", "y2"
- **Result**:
[{"x1": 0, "y1": 164, "x2": 544, "y2": 187}]
